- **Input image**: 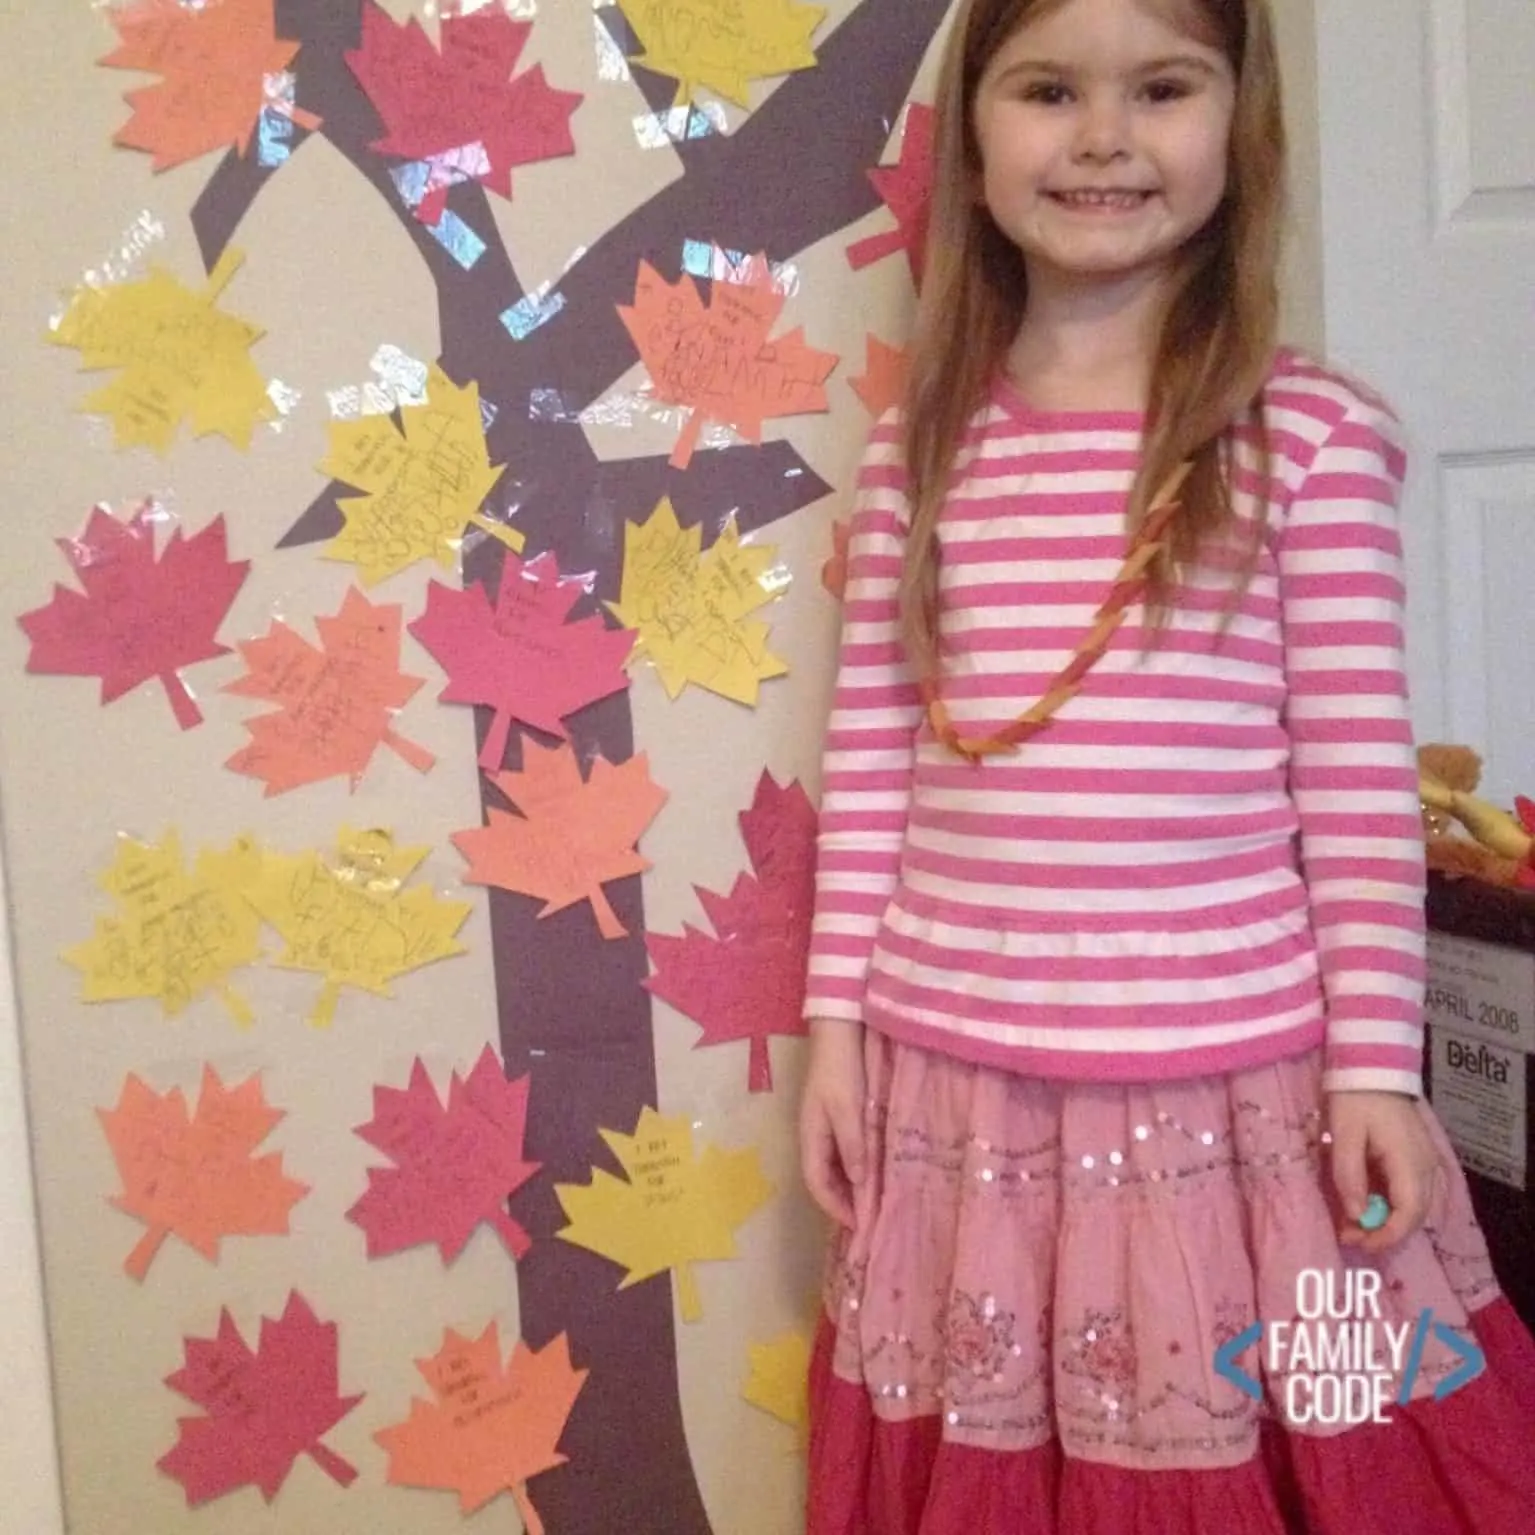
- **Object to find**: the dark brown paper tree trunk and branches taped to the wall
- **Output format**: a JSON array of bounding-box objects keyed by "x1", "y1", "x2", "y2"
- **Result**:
[{"x1": 181, "y1": 0, "x2": 949, "y2": 1535}]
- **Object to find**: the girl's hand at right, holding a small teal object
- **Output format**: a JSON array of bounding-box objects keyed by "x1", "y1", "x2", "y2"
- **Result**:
[{"x1": 1328, "y1": 1093, "x2": 1438, "y2": 1253}]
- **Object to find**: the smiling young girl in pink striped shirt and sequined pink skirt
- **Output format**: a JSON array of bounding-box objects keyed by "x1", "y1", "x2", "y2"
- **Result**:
[{"x1": 801, "y1": 0, "x2": 1535, "y2": 1535}]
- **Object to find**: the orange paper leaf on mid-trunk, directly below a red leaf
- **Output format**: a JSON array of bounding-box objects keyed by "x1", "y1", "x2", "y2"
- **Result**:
[{"x1": 453, "y1": 738, "x2": 666, "y2": 938}]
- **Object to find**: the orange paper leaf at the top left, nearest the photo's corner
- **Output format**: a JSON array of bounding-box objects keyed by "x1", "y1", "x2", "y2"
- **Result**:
[{"x1": 101, "y1": 0, "x2": 318, "y2": 170}]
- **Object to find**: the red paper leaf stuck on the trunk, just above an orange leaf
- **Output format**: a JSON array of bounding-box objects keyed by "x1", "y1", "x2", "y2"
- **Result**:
[{"x1": 410, "y1": 550, "x2": 634, "y2": 772}]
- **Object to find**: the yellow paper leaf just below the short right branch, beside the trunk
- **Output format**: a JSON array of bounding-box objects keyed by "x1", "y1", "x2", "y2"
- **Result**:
[{"x1": 608, "y1": 499, "x2": 789, "y2": 708}]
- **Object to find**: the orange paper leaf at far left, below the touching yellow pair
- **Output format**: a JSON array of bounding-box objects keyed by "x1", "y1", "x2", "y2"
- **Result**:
[{"x1": 97, "y1": 1067, "x2": 309, "y2": 1279}]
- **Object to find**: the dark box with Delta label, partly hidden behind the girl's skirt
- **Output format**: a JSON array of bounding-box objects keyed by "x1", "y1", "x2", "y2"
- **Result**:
[{"x1": 1424, "y1": 873, "x2": 1535, "y2": 1329}]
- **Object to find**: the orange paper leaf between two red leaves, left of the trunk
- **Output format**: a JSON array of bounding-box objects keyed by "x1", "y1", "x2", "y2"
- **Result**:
[{"x1": 224, "y1": 589, "x2": 436, "y2": 795}]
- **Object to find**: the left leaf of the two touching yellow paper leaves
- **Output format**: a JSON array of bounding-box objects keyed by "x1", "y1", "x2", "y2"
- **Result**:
[{"x1": 63, "y1": 829, "x2": 261, "y2": 1025}]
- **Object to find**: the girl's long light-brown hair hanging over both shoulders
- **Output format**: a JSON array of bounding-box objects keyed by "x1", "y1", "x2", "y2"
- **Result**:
[{"x1": 901, "y1": 0, "x2": 1285, "y2": 675}]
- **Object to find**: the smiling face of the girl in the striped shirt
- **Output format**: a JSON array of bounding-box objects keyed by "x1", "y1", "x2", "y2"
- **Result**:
[{"x1": 973, "y1": 0, "x2": 1236, "y2": 286}]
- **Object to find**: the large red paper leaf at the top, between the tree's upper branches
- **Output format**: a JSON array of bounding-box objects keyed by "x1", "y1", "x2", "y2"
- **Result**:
[{"x1": 347, "y1": 0, "x2": 583, "y2": 198}]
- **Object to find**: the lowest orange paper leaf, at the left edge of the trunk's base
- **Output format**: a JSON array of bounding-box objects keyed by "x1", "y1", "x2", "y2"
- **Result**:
[{"x1": 373, "y1": 1322, "x2": 588, "y2": 1535}]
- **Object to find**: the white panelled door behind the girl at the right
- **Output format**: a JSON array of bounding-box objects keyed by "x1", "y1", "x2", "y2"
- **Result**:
[{"x1": 1307, "y1": 0, "x2": 1535, "y2": 803}]
